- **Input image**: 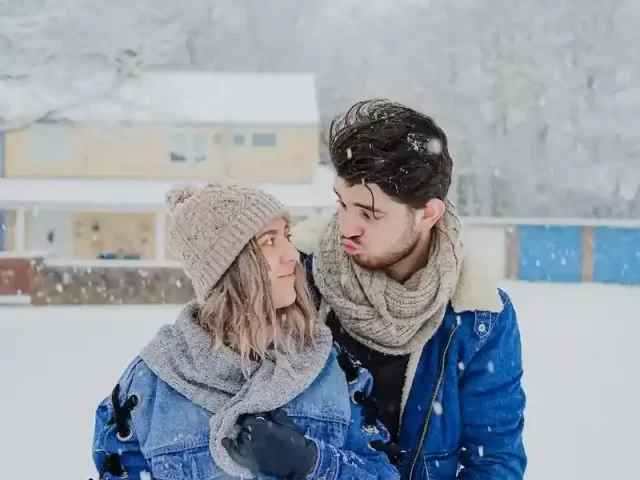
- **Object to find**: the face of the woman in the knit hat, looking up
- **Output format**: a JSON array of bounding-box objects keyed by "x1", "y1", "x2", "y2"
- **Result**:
[{"x1": 255, "y1": 218, "x2": 300, "y2": 309}]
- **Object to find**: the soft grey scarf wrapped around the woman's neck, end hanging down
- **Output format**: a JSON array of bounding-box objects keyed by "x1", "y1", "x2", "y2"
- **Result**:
[{"x1": 140, "y1": 303, "x2": 332, "y2": 478}]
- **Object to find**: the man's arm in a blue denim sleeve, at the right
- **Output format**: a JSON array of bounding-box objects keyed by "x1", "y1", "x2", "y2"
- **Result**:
[{"x1": 458, "y1": 291, "x2": 527, "y2": 480}]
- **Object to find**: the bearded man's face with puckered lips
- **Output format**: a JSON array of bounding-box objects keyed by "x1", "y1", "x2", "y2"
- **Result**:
[{"x1": 334, "y1": 177, "x2": 424, "y2": 270}]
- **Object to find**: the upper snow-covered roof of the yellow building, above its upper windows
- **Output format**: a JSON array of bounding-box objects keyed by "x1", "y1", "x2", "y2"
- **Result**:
[{"x1": 0, "y1": 71, "x2": 320, "y2": 125}]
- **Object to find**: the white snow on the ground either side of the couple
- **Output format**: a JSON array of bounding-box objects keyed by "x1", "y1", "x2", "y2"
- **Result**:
[{"x1": 0, "y1": 282, "x2": 640, "y2": 480}]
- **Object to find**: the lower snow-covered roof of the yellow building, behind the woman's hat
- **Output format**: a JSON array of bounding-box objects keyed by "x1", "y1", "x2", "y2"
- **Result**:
[{"x1": 0, "y1": 165, "x2": 335, "y2": 215}]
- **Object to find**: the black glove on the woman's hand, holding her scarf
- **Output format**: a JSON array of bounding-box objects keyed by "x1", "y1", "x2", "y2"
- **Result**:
[{"x1": 222, "y1": 409, "x2": 318, "y2": 480}]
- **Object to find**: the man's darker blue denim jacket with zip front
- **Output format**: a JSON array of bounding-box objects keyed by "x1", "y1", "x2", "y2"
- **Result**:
[{"x1": 301, "y1": 253, "x2": 527, "y2": 480}]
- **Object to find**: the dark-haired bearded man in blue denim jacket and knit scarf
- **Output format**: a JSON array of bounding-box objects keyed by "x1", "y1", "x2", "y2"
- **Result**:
[{"x1": 292, "y1": 101, "x2": 527, "y2": 480}]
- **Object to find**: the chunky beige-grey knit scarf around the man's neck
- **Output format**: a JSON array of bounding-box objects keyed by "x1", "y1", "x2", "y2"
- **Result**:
[{"x1": 313, "y1": 202, "x2": 463, "y2": 355}]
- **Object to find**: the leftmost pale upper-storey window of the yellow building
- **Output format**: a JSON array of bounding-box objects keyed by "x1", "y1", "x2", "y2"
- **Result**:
[{"x1": 28, "y1": 123, "x2": 71, "y2": 163}]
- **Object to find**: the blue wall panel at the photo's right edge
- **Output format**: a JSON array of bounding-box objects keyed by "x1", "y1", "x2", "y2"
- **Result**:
[{"x1": 593, "y1": 227, "x2": 640, "y2": 284}]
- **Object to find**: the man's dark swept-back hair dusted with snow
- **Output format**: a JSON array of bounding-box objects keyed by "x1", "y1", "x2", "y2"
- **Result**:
[{"x1": 328, "y1": 100, "x2": 453, "y2": 208}]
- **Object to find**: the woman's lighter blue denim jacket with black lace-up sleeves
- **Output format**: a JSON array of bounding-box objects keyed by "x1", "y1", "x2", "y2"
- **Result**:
[{"x1": 93, "y1": 348, "x2": 400, "y2": 480}]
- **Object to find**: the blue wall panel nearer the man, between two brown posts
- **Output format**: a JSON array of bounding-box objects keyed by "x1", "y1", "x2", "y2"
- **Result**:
[{"x1": 519, "y1": 225, "x2": 583, "y2": 282}]
